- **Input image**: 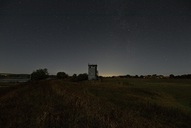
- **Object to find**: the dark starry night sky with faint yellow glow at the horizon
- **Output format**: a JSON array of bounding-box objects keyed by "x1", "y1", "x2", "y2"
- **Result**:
[{"x1": 0, "y1": 0, "x2": 191, "y2": 75}]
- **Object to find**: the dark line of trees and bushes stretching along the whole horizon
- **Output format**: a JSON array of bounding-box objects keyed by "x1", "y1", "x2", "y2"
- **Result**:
[{"x1": 0, "y1": 68, "x2": 191, "y2": 82}]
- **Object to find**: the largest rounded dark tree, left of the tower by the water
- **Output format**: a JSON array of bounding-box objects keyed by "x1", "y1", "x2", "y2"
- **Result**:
[{"x1": 31, "y1": 68, "x2": 48, "y2": 80}]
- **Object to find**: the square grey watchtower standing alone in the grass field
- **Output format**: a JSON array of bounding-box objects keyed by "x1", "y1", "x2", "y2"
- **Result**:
[{"x1": 88, "y1": 64, "x2": 98, "y2": 80}]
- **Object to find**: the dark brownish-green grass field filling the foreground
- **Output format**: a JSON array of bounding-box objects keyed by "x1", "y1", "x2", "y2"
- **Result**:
[{"x1": 0, "y1": 78, "x2": 191, "y2": 128}]
